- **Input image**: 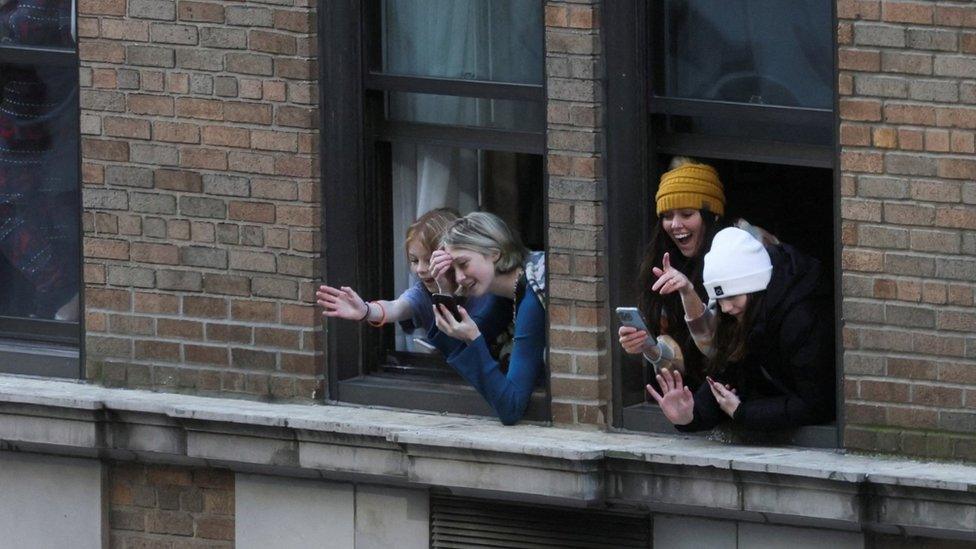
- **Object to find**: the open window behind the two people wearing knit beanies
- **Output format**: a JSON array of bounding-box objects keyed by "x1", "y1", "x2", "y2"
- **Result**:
[{"x1": 604, "y1": 0, "x2": 839, "y2": 446}]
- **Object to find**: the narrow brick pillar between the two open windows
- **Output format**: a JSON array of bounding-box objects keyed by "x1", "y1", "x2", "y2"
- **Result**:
[{"x1": 545, "y1": 1, "x2": 611, "y2": 425}]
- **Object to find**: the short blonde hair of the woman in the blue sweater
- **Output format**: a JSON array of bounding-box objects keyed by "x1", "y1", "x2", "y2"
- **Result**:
[{"x1": 441, "y1": 212, "x2": 529, "y2": 273}]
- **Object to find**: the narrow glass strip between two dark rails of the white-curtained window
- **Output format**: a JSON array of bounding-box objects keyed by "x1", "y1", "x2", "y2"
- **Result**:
[{"x1": 387, "y1": 92, "x2": 546, "y2": 132}]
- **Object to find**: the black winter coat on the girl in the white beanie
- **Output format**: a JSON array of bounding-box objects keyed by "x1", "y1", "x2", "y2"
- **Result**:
[{"x1": 678, "y1": 244, "x2": 835, "y2": 431}]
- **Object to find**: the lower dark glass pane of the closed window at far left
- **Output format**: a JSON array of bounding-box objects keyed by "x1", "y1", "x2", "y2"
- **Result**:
[{"x1": 0, "y1": 65, "x2": 80, "y2": 322}]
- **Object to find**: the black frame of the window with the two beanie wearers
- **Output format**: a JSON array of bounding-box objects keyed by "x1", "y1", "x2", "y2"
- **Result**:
[{"x1": 603, "y1": 0, "x2": 844, "y2": 448}]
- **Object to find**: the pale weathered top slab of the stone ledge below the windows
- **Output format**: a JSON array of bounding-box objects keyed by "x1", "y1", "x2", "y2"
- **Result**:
[{"x1": 0, "y1": 375, "x2": 976, "y2": 493}]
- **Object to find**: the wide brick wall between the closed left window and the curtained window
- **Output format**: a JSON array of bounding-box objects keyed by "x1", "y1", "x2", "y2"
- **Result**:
[{"x1": 78, "y1": 0, "x2": 323, "y2": 400}]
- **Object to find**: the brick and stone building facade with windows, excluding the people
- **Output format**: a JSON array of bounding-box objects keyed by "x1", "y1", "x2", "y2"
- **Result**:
[{"x1": 0, "y1": 0, "x2": 976, "y2": 548}]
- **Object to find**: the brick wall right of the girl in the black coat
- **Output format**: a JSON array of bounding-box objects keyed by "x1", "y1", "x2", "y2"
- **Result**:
[{"x1": 837, "y1": 0, "x2": 976, "y2": 459}]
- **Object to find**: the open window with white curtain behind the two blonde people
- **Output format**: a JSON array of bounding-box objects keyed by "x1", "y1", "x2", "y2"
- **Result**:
[{"x1": 320, "y1": 0, "x2": 548, "y2": 419}]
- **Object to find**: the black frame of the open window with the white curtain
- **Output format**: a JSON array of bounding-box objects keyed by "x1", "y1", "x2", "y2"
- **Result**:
[{"x1": 318, "y1": 0, "x2": 551, "y2": 421}]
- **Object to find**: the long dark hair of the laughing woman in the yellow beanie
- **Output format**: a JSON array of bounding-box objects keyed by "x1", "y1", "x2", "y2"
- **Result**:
[{"x1": 637, "y1": 210, "x2": 723, "y2": 387}]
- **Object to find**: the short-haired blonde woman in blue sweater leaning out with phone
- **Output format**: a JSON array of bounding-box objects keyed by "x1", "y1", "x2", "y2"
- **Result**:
[{"x1": 430, "y1": 212, "x2": 546, "y2": 425}]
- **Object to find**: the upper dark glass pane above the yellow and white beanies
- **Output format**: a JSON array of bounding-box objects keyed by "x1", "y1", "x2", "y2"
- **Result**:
[{"x1": 659, "y1": 0, "x2": 834, "y2": 108}]
